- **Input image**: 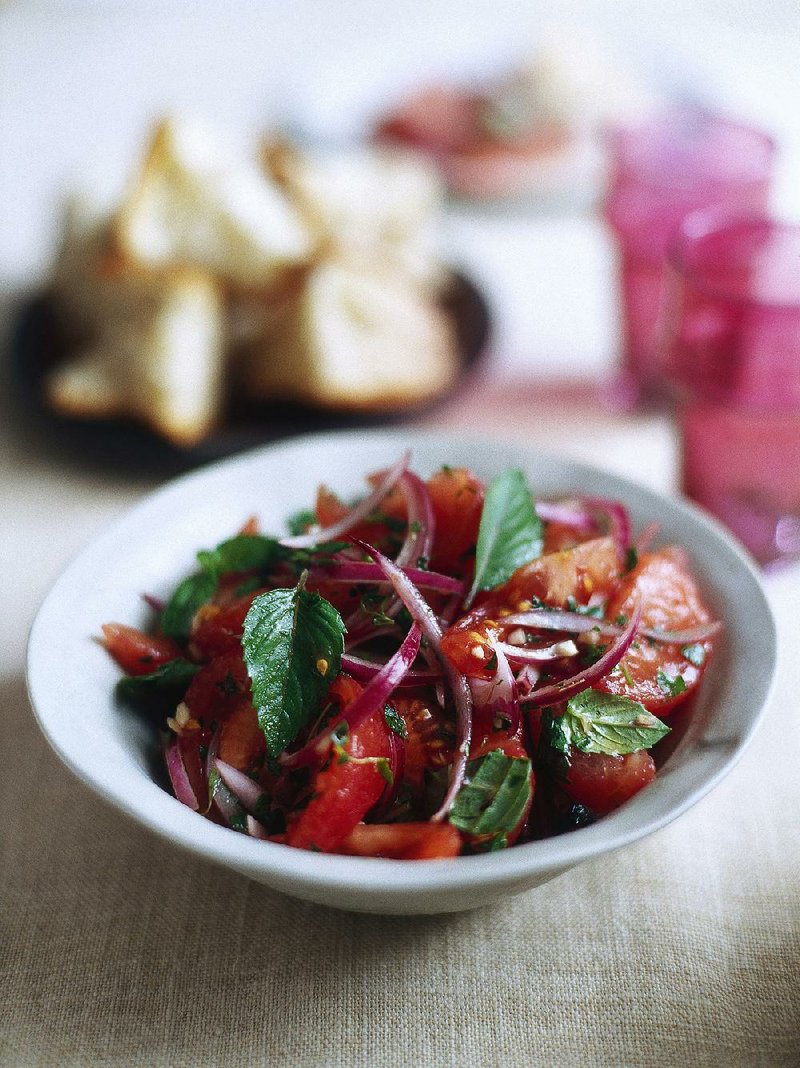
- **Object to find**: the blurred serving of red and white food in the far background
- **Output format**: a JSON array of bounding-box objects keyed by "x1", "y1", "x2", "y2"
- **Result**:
[{"x1": 375, "y1": 34, "x2": 655, "y2": 201}]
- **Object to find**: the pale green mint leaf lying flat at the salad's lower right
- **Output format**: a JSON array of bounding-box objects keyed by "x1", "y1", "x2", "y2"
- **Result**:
[{"x1": 549, "y1": 690, "x2": 670, "y2": 757}]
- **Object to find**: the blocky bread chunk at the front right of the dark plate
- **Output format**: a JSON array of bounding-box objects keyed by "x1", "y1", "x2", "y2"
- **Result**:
[{"x1": 242, "y1": 261, "x2": 456, "y2": 411}]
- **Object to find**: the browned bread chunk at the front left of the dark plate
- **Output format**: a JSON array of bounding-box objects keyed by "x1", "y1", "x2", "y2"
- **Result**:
[{"x1": 45, "y1": 269, "x2": 223, "y2": 445}]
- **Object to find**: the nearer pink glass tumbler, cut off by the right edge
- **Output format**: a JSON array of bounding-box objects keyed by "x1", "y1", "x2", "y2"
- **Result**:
[{"x1": 665, "y1": 213, "x2": 800, "y2": 564}]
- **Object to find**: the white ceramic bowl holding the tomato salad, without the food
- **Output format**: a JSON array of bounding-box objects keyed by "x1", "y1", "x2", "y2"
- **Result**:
[{"x1": 28, "y1": 431, "x2": 775, "y2": 913}]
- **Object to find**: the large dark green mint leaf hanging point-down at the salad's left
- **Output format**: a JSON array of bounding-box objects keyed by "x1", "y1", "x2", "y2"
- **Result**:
[{"x1": 241, "y1": 580, "x2": 345, "y2": 756}]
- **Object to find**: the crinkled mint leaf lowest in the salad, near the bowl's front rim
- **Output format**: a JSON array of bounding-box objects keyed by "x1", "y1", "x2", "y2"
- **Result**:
[{"x1": 449, "y1": 749, "x2": 531, "y2": 836}]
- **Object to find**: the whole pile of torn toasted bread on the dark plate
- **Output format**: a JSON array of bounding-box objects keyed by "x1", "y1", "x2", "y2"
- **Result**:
[{"x1": 44, "y1": 117, "x2": 458, "y2": 446}]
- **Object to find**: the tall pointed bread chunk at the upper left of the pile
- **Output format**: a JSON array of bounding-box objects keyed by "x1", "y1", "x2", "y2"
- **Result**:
[{"x1": 114, "y1": 119, "x2": 313, "y2": 289}]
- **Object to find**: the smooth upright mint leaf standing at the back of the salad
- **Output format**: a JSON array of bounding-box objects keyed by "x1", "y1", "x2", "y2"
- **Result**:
[{"x1": 465, "y1": 468, "x2": 543, "y2": 608}]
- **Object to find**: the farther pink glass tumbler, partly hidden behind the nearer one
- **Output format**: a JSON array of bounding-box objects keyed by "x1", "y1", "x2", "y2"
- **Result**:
[{"x1": 605, "y1": 110, "x2": 774, "y2": 406}]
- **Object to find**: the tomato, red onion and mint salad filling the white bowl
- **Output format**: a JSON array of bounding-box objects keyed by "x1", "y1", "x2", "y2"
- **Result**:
[{"x1": 103, "y1": 454, "x2": 720, "y2": 860}]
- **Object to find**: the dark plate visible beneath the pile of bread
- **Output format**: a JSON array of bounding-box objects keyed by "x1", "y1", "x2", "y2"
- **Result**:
[{"x1": 10, "y1": 272, "x2": 490, "y2": 472}]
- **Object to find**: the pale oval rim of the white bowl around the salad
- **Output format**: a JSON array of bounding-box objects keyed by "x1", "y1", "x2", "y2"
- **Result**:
[{"x1": 27, "y1": 429, "x2": 778, "y2": 898}]
